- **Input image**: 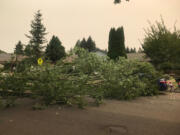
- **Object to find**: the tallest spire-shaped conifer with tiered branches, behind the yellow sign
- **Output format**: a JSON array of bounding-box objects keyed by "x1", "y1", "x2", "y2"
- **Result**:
[{"x1": 26, "y1": 10, "x2": 47, "y2": 58}]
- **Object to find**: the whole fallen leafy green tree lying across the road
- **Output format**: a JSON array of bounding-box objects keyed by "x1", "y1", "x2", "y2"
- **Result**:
[{"x1": 0, "y1": 48, "x2": 158, "y2": 109}]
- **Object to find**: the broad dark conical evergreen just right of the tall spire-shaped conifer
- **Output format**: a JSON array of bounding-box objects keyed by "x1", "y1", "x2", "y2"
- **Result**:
[{"x1": 45, "y1": 36, "x2": 66, "y2": 62}]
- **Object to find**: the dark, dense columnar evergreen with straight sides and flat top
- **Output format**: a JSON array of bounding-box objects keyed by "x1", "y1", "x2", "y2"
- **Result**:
[{"x1": 108, "y1": 27, "x2": 127, "y2": 59}]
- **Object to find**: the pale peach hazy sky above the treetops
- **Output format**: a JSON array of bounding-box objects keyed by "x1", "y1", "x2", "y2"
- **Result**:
[{"x1": 0, "y1": 0, "x2": 180, "y2": 52}]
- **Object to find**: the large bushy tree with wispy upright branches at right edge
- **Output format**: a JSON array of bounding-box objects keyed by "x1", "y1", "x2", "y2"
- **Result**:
[{"x1": 142, "y1": 19, "x2": 180, "y2": 71}]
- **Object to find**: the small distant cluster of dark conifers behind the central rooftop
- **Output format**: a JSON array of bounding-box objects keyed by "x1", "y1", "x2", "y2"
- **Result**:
[{"x1": 75, "y1": 36, "x2": 96, "y2": 52}]
